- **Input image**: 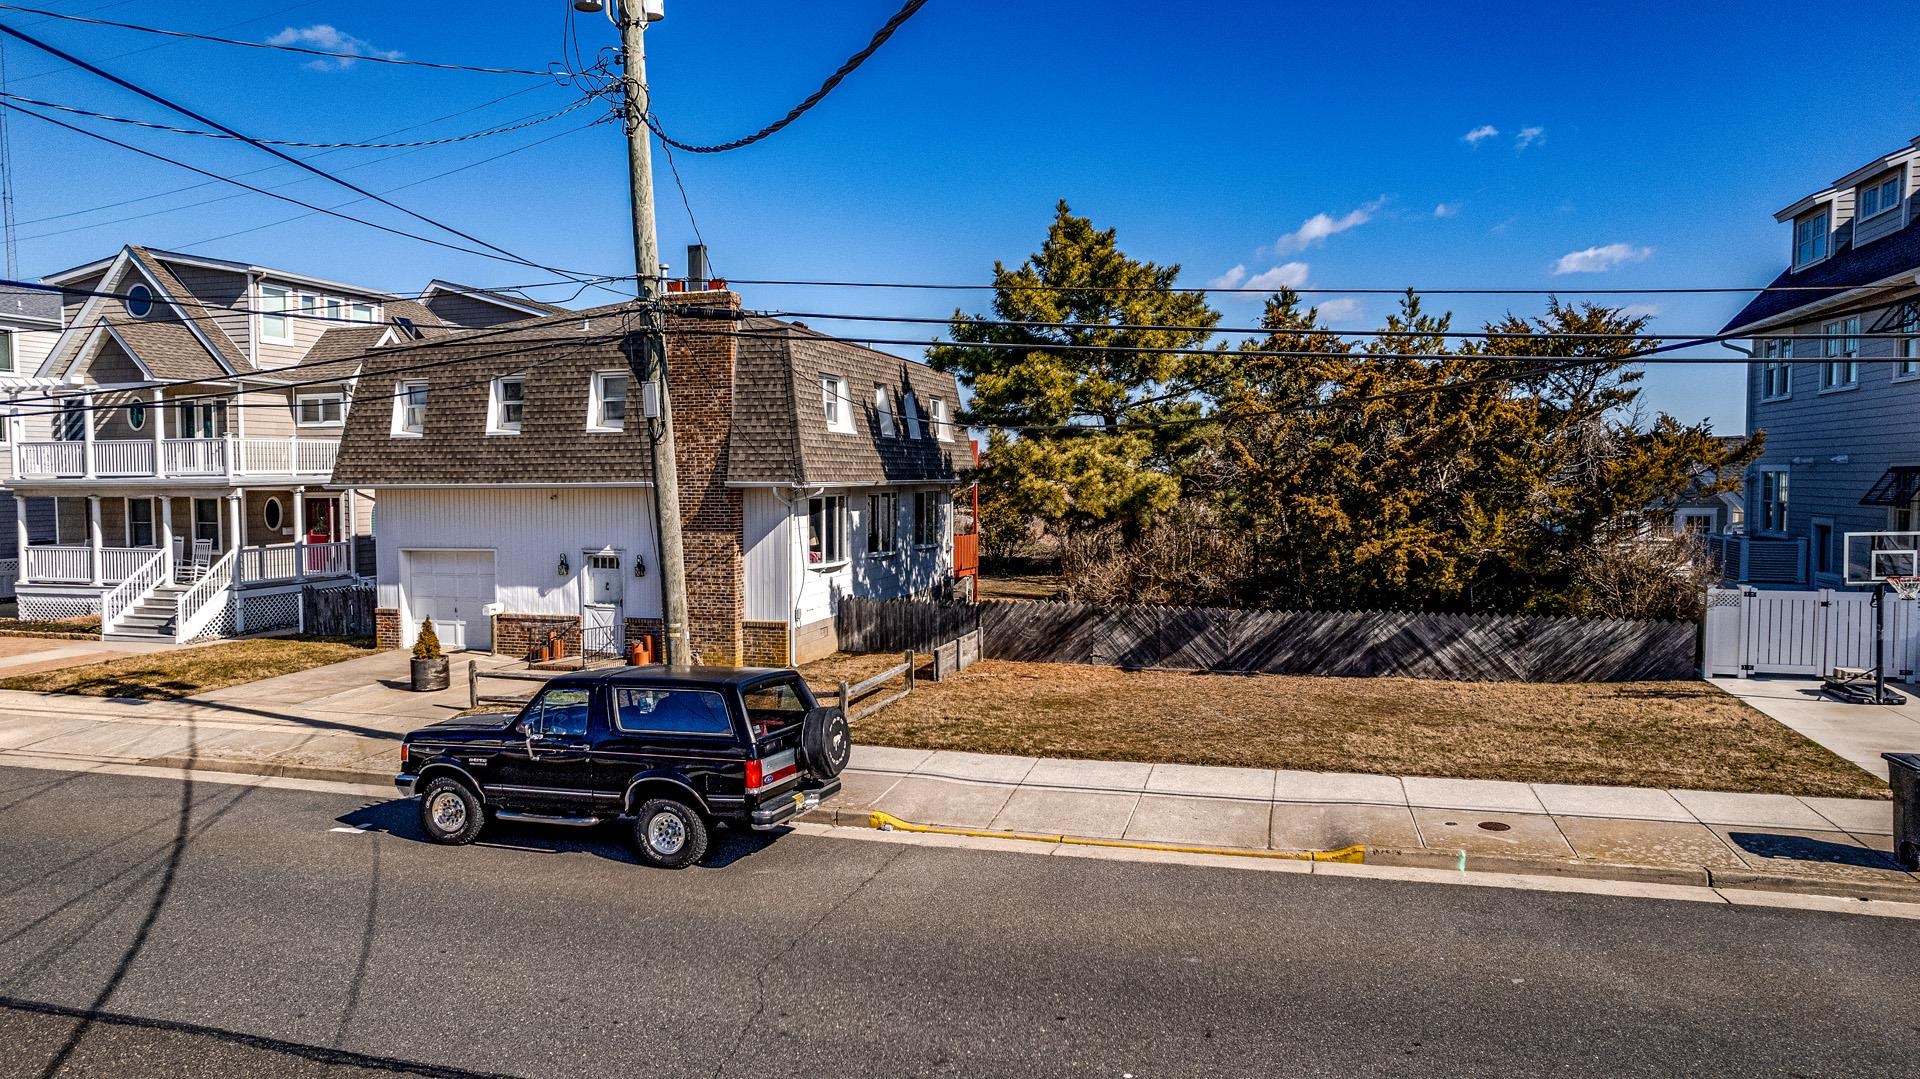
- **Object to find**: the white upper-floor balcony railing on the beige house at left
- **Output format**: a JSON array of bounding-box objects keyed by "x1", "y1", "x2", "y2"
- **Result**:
[{"x1": 13, "y1": 436, "x2": 340, "y2": 480}]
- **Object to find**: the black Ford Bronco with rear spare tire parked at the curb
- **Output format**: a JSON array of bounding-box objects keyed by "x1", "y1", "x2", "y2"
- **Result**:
[{"x1": 394, "y1": 666, "x2": 852, "y2": 870}]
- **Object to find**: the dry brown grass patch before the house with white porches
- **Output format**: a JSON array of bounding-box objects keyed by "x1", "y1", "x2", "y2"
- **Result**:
[{"x1": 0, "y1": 637, "x2": 372, "y2": 701}]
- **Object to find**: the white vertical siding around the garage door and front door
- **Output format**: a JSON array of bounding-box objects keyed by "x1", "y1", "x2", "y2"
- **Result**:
[{"x1": 376, "y1": 488, "x2": 660, "y2": 618}]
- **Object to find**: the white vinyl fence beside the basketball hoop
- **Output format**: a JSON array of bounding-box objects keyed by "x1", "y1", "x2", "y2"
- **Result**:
[{"x1": 1701, "y1": 587, "x2": 1920, "y2": 682}]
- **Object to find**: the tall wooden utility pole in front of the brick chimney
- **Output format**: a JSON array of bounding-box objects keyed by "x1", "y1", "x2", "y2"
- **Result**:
[{"x1": 612, "y1": 0, "x2": 689, "y2": 662}]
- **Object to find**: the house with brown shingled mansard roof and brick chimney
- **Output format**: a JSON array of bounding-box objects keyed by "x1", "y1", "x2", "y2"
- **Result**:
[{"x1": 334, "y1": 292, "x2": 958, "y2": 666}]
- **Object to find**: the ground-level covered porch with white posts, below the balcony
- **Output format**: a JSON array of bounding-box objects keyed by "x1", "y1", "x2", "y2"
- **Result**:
[{"x1": 13, "y1": 486, "x2": 359, "y2": 589}]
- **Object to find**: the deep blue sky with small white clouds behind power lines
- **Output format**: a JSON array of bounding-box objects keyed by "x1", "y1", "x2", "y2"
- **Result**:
[{"x1": 0, "y1": 0, "x2": 1920, "y2": 432}]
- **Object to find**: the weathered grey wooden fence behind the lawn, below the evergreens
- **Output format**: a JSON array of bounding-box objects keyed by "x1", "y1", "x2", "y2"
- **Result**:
[{"x1": 837, "y1": 599, "x2": 1697, "y2": 682}]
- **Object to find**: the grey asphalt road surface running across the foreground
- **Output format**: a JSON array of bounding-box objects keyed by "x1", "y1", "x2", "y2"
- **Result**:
[{"x1": 0, "y1": 768, "x2": 1920, "y2": 1079}]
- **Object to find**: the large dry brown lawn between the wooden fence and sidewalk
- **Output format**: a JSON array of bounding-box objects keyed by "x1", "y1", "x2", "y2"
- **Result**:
[{"x1": 804, "y1": 653, "x2": 1889, "y2": 799}]
